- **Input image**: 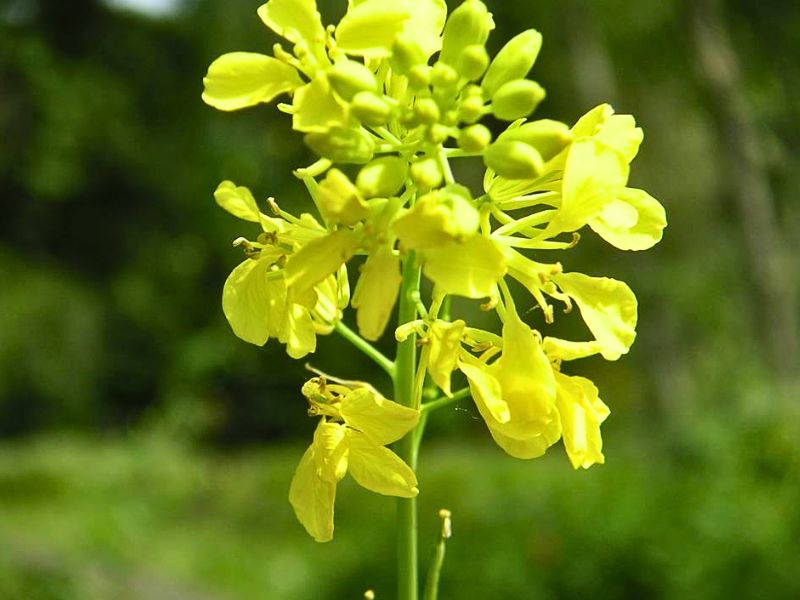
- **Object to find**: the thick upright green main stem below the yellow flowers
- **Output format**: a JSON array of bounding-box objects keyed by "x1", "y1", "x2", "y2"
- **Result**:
[{"x1": 392, "y1": 252, "x2": 420, "y2": 600}]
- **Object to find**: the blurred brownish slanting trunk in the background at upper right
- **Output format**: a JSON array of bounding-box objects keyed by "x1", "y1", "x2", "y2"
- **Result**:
[{"x1": 684, "y1": 0, "x2": 798, "y2": 373}]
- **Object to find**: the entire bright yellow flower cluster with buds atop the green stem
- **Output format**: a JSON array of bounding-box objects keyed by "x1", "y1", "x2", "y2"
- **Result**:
[{"x1": 203, "y1": 0, "x2": 666, "y2": 540}]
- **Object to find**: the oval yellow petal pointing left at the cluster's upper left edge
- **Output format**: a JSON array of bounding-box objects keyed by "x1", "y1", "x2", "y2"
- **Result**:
[{"x1": 203, "y1": 52, "x2": 303, "y2": 111}]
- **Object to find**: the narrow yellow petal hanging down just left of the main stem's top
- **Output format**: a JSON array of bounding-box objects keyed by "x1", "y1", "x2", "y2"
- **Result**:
[{"x1": 353, "y1": 245, "x2": 402, "y2": 341}]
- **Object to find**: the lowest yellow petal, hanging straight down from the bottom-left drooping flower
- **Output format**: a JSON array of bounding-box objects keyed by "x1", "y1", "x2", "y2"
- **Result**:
[{"x1": 289, "y1": 446, "x2": 336, "y2": 542}]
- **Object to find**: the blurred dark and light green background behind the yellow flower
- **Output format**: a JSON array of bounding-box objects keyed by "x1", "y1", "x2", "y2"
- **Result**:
[{"x1": 0, "y1": 0, "x2": 800, "y2": 600}]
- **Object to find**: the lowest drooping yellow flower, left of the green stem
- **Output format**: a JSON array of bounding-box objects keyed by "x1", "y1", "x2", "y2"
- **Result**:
[{"x1": 289, "y1": 380, "x2": 419, "y2": 542}]
